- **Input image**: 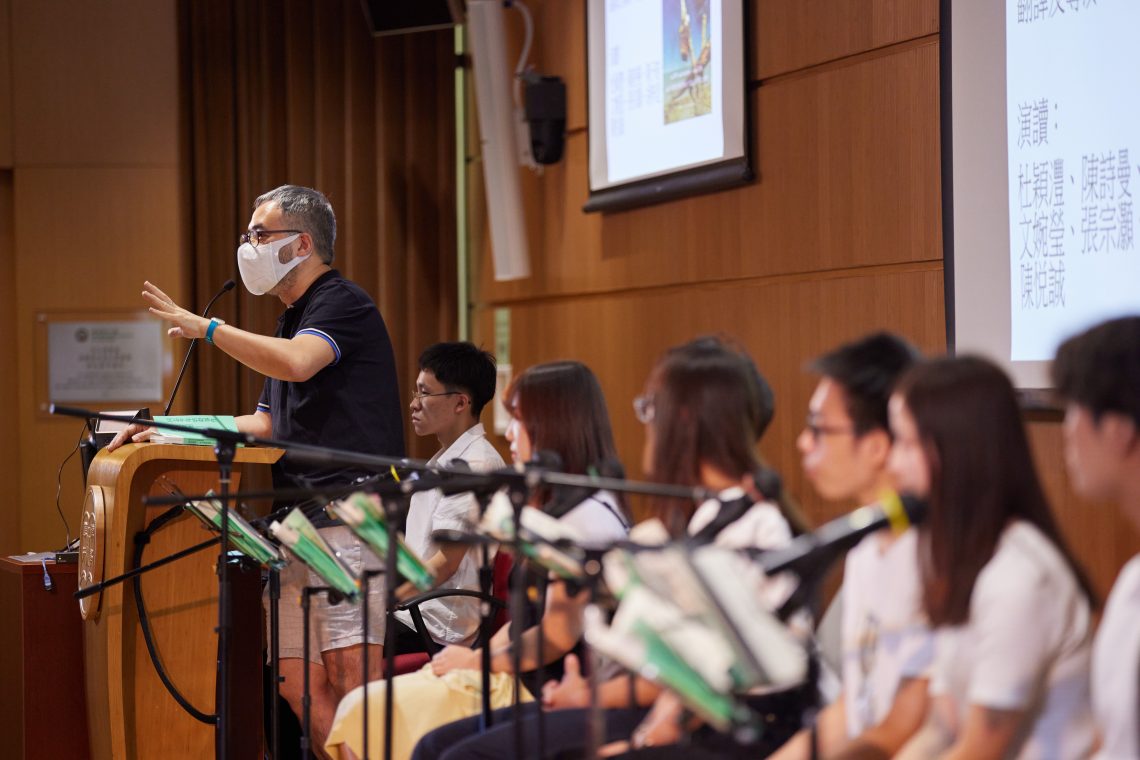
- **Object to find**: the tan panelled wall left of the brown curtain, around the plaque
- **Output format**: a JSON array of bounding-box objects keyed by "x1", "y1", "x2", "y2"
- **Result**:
[{"x1": 0, "y1": 0, "x2": 187, "y2": 551}]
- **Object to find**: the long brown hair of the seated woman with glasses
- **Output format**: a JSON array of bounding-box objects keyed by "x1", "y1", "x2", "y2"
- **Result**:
[{"x1": 648, "y1": 337, "x2": 806, "y2": 533}]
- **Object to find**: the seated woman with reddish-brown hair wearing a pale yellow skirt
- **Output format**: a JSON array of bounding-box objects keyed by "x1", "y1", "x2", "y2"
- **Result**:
[{"x1": 325, "y1": 361, "x2": 628, "y2": 758}]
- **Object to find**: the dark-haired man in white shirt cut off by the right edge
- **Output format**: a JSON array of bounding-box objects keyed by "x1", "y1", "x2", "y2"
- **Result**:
[{"x1": 1052, "y1": 316, "x2": 1140, "y2": 760}]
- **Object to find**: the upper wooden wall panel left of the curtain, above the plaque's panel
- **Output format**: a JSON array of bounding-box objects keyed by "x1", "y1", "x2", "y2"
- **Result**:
[{"x1": 10, "y1": 0, "x2": 178, "y2": 165}]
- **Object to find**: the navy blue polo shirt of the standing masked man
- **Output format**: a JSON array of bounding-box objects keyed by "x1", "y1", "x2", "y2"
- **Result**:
[{"x1": 258, "y1": 270, "x2": 404, "y2": 515}]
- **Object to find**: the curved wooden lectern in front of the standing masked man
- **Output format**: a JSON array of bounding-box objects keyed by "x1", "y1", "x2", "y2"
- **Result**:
[{"x1": 79, "y1": 443, "x2": 282, "y2": 760}]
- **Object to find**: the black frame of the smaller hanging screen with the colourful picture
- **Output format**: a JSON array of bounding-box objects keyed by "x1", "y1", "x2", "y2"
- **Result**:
[{"x1": 583, "y1": 0, "x2": 758, "y2": 213}]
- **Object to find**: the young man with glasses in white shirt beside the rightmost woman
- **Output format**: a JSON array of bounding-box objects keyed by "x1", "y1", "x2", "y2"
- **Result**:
[{"x1": 772, "y1": 333, "x2": 934, "y2": 760}]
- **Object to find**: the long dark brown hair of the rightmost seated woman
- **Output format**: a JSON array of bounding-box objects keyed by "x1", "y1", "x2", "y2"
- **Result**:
[{"x1": 896, "y1": 357, "x2": 1096, "y2": 626}]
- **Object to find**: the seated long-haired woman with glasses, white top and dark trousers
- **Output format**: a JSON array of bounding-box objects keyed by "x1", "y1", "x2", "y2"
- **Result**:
[{"x1": 414, "y1": 337, "x2": 801, "y2": 760}]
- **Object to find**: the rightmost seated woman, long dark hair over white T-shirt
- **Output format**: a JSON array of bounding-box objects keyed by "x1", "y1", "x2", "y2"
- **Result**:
[{"x1": 889, "y1": 358, "x2": 1093, "y2": 760}]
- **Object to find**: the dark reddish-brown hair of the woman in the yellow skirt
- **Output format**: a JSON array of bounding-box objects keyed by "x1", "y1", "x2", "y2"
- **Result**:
[{"x1": 503, "y1": 361, "x2": 617, "y2": 508}]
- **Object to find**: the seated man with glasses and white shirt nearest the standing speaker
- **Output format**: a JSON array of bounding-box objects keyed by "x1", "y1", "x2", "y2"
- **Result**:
[{"x1": 396, "y1": 343, "x2": 504, "y2": 646}]
